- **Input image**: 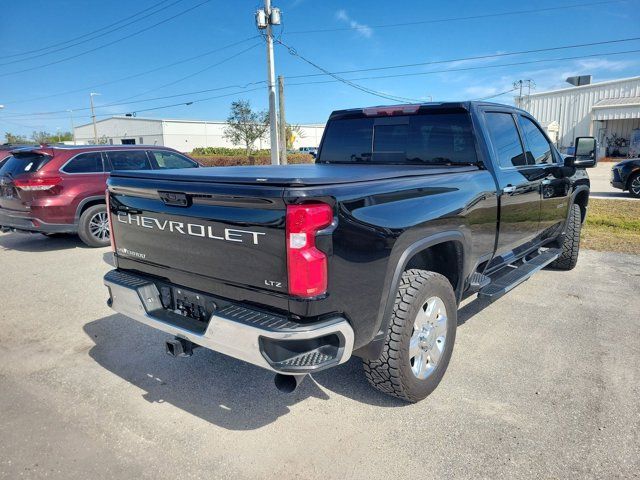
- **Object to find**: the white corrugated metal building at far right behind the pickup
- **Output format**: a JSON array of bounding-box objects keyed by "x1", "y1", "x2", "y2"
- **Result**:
[{"x1": 516, "y1": 77, "x2": 640, "y2": 157}]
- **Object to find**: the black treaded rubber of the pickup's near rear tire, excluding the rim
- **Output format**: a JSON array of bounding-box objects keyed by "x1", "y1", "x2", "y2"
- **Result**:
[{"x1": 363, "y1": 269, "x2": 458, "y2": 402}]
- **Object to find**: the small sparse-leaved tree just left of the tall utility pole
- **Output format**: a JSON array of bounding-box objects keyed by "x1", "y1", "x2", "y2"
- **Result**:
[{"x1": 224, "y1": 100, "x2": 269, "y2": 155}]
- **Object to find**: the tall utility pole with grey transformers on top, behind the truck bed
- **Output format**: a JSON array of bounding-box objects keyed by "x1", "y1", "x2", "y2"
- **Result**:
[{"x1": 256, "y1": 0, "x2": 280, "y2": 165}]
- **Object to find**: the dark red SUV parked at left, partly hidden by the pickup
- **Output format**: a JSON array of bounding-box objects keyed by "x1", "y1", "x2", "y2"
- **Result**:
[{"x1": 0, "y1": 145, "x2": 199, "y2": 247}]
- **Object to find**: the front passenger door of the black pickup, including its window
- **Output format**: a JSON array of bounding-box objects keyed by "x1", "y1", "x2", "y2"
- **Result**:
[{"x1": 517, "y1": 115, "x2": 571, "y2": 241}]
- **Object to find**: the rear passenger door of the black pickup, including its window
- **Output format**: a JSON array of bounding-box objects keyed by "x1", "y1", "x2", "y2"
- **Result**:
[{"x1": 484, "y1": 110, "x2": 542, "y2": 258}]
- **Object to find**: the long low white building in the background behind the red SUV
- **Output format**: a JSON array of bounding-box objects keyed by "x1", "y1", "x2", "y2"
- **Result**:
[{"x1": 74, "y1": 116, "x2": 324, "y2": 153}]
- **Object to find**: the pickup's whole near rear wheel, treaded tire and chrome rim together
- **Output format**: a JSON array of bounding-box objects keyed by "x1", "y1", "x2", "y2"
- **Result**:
[{"x1": 364, "y1": 269, "x2": 457, "y2": 402}]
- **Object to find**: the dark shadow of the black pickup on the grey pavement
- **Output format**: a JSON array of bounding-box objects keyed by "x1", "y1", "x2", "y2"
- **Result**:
[{"x1": 84, "y1": 301, "x2": 487, "y2": 430}]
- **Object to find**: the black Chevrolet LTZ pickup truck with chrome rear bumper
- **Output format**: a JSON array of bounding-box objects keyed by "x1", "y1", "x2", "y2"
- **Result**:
[{"x1": 104, "y1": 102, "x2": 595, "y2": 402}]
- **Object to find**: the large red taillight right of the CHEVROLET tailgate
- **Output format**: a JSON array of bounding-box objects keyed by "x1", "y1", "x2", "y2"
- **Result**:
[{"x1": 287, "y1": 203, "x2": 333, "y2": 297}]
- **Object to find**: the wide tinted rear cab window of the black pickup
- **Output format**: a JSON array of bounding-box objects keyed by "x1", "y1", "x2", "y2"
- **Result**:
[{"x1": 316, "y1": 109, "x2": 477, "y2": 165}]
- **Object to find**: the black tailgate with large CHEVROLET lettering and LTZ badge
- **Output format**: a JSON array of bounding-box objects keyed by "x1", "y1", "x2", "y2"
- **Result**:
[{"x1": 108, "y1": 174, "x2": 287, "y2": 293}]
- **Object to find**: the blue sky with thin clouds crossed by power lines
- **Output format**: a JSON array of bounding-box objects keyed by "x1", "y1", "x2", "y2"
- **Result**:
[{"x1": 0, "y1": 0, "x2": 640, "y2": 142}]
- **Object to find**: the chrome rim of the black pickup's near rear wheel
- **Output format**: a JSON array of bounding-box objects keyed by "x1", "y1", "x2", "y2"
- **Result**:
[{"x1": 409, "y1": 297, "x2": 447, "y2": 380}]
